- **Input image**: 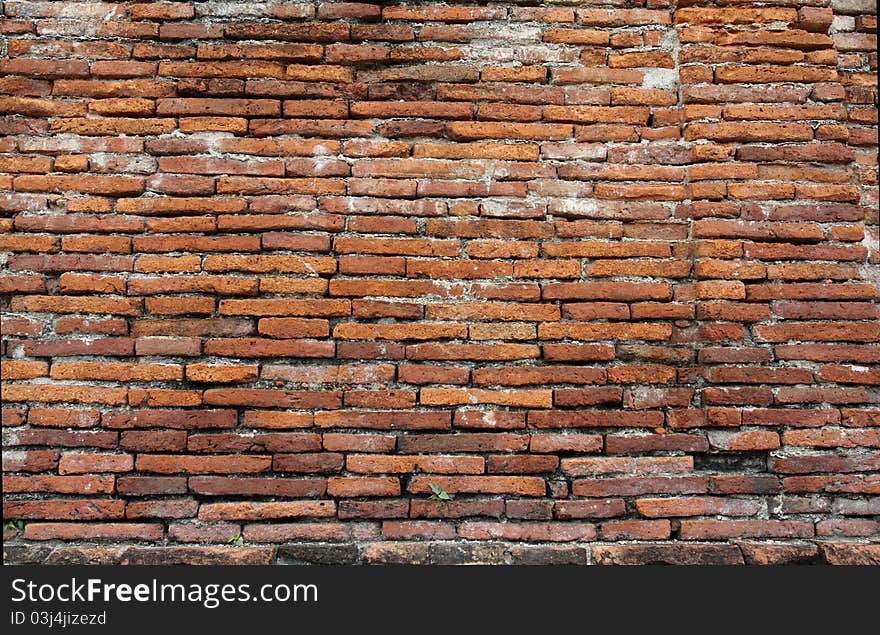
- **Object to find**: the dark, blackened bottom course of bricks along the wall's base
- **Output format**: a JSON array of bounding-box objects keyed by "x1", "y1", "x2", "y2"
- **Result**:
[{"x1": 3, "y1": 541, "x2": 880, "y2": 565}]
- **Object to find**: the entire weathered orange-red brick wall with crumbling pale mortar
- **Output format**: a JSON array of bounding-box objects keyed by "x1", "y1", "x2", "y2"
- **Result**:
[{"x1": 0, "y1": 0, "x2": 880, "y2": 563}]
